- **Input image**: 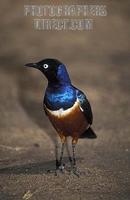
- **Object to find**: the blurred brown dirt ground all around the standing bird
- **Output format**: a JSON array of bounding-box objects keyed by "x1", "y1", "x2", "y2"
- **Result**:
[{"x1": 0, "y1": 0, "x2": 130, "y2": 200}]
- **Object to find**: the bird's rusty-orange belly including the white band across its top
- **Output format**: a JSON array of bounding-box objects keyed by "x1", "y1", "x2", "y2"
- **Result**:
[{"x1": 45, "y1": 102, "x2": 89, "y2": 139}]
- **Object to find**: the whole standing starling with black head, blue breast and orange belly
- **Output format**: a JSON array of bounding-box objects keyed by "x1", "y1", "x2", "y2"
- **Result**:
[{"x1": 25, "y1": 58, "x2": 96, "y2": 176}]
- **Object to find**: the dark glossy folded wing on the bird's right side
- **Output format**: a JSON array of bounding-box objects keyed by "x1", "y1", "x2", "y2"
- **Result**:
[{"x1": 75, "y1": 88, "x2": 93, "y2": 125}]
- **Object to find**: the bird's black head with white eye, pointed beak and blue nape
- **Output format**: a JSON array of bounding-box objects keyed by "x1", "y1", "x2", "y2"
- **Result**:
[{"x1": 25, "y1": 58, "x2": 70, "y2": 84}]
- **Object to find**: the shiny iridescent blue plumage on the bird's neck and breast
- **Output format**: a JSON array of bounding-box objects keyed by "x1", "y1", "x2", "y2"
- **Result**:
[{"x1": 44, "y1": 65, "x2": 76, "y2": 110}]
